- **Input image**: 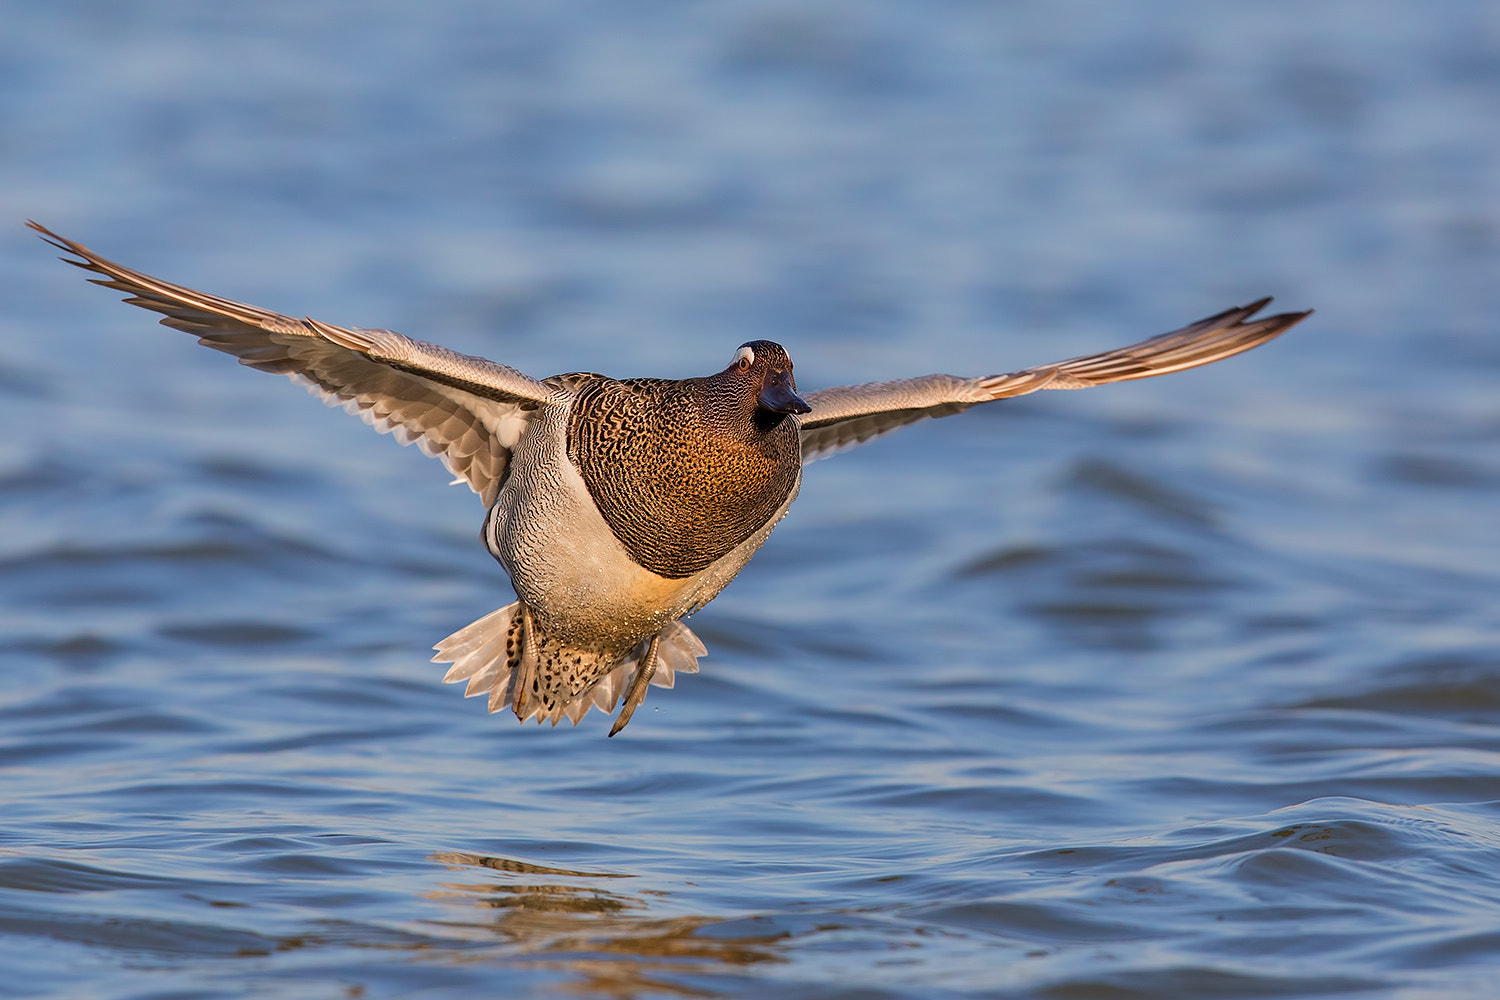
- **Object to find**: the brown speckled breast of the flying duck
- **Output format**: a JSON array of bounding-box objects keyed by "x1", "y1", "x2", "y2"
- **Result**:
[{"x1": 567, "y1": 378, "x2": 801, "y2": 579}]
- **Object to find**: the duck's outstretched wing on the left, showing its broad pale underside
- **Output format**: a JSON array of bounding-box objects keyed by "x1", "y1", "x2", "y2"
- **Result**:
[{"x1": 27, "y1": 222, "x2": 560, "y2": 507}]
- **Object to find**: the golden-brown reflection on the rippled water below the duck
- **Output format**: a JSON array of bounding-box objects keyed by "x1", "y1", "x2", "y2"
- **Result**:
[{"x1": 426, "y1": 852, "x2": 788, "y2": 997}]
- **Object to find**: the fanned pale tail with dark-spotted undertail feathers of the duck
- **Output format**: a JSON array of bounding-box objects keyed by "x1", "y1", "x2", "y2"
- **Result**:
[{"x1": 432, "y1": 601, "x2": 708, "y2": 726}]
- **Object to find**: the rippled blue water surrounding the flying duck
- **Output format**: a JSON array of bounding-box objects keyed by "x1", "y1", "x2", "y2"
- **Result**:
[{"x1": 0, "y1": 0, "x2": 1500, "y2": 1000}]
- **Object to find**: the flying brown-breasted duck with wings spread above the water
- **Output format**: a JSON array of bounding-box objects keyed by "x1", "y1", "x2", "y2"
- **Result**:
[{"x1": 27, "y1": 222, "x2": 1311, "y2": 736}]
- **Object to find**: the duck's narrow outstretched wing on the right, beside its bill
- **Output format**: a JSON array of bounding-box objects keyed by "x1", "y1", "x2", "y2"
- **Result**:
[{"x1": 800, "y1": 298, "x2": 1313, "y2": 465}]
